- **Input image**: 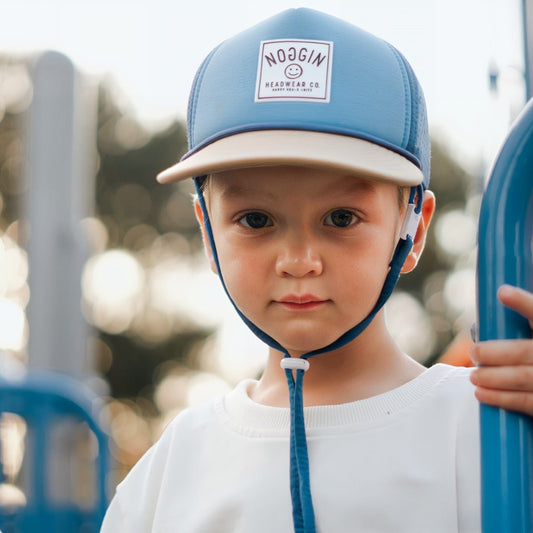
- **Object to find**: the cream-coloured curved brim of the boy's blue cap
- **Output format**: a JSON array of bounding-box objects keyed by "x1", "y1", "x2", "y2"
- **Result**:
[{"x1": 157, "y1": 130, "x2": 424, "y2": 186}]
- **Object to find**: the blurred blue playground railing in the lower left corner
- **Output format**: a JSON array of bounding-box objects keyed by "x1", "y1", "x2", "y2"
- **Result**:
[{"x1": 0, "y1": 373, "x2": 109, "y2": 533}]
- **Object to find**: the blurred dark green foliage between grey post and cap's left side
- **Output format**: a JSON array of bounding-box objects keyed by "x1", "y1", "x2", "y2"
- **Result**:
[{"x1": 96, "y1": 85, "x2": 198, "y2": 247}]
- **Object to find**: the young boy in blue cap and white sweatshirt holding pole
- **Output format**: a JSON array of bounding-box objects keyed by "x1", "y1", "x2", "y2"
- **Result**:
[{"x1": 102, "y1": 9, "x2": 533, "y2": 533}]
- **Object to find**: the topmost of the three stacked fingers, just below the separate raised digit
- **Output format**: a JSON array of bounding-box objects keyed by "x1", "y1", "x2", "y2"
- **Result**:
[{"x1": 470, "y1": 339, "x2": 533, "y2": 366}]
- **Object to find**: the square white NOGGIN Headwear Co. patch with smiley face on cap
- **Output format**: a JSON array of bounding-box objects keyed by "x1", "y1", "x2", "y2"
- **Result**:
[{"x1": 255, "y1": 39, "x2": 333, "y2": 103}]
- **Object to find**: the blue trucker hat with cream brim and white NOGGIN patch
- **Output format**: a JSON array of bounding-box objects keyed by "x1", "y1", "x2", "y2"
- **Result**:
[{"x1": 158, "y1": 8, "x2": 430, "y2": 188}]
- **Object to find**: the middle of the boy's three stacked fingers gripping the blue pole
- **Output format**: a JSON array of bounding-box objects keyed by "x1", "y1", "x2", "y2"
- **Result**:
[{"x1": 470, "y1": 366, "x2": 533, "y2": 390}]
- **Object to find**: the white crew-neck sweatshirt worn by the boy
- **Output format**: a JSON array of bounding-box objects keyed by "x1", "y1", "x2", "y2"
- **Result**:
[{"x1": 101, "y1": 364, "x2": 481, "y2": 533}]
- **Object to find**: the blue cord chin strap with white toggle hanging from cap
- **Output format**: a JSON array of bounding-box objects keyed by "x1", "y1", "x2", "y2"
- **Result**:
[{"x1": 194, "y1": 178, "x2": 424, "y2": 533}]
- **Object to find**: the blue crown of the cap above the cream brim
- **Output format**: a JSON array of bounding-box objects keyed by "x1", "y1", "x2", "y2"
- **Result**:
[{"x1": 188, "y1": 8, "x2": 429, "y2": 186}]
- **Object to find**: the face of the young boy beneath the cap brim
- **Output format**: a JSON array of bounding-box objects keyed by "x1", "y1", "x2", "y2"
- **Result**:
[{"x1": 202, "y1": 166, "x2": 402, "y2": 356}]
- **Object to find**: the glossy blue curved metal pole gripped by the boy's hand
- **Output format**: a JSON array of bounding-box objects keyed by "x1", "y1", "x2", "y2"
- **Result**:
[{"x1": 477, "y1": 96, "x2": 533, "y2": 533}]
